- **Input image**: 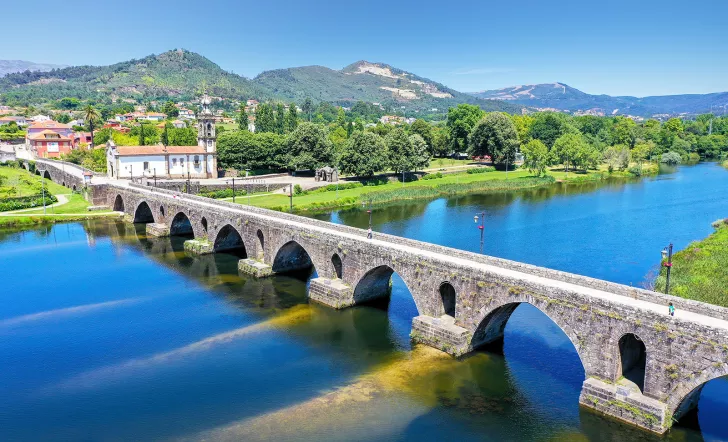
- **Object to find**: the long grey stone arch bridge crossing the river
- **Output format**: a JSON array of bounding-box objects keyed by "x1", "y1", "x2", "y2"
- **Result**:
[{"x1": 34, "y1": 161, "x2": 728, "y2": 433}]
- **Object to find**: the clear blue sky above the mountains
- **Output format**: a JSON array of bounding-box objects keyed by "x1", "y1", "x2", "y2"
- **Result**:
[{"x1": 0, "y1": 0, "x2": 728, "y2": 96}]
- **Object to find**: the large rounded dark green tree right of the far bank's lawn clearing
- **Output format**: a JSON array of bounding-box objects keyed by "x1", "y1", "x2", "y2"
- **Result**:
[{"x1": 468, "y1": 112, "x2": 519, "y2": 168}]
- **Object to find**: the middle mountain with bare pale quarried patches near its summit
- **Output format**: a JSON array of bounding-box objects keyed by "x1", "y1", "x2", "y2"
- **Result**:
[{"x1": 253, "y1": 61, "x2": 523, "y2": 112}]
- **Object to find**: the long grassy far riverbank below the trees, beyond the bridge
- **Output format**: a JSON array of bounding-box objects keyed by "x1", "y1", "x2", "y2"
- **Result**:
[{"x1": 238, "y1": 164, "x2": 658, "y2": 213}]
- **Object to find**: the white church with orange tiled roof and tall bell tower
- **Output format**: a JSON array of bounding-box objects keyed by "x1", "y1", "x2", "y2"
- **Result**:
[{"x1": 106, "y1": 96, "x2": 217, "y2": 179}]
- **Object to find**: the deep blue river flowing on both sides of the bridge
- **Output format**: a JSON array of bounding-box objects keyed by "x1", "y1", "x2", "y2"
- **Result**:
[{"x1": 0, "y1": 163, "x2": 728, "y2": 441}]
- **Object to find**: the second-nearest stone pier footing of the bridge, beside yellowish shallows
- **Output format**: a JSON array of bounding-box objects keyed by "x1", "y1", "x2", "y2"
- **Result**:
[{"x1": 410, "y1": 315, "x2": 471, "y2": 356}]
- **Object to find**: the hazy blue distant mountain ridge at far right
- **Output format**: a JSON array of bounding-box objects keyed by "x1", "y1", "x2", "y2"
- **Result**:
[{"x1": 471, "y1": 83, "x2": 728, "y2": 117}]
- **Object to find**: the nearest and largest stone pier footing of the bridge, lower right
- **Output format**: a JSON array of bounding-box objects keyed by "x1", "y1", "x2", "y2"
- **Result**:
[{"x1": 579, "y1": 377, "x2": 672, "y2": 434}]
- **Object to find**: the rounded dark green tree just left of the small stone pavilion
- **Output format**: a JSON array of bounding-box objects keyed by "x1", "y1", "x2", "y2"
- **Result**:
[{"x1": 288, "y1": 123, "x2": 334, "y2": 170}]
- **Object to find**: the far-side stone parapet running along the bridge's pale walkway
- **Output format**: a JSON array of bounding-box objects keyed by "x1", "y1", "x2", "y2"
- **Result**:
[{"x1": 122, "y1": 184, "x2": 728, "y2": 321}]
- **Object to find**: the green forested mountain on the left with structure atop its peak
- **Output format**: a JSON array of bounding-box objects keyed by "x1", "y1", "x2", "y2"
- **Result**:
[{"x1": 0, "y1": 49, "x2": 266, "y2": 103}]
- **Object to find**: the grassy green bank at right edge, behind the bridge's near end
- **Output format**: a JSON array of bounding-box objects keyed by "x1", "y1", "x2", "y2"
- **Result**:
[{"x1": 655, "y1": 219, "x2": 728, "y2": 307}]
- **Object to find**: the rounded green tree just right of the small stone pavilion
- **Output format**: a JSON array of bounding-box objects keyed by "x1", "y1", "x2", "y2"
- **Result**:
[{"x1": 339, "y1": 132, "x2": 387, "y2": 177}]
